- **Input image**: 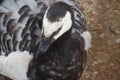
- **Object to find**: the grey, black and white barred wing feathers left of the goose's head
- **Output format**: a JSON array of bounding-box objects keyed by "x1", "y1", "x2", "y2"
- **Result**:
[{"x1": 0, "y1": 0, "x2": 47, "y2": 56}]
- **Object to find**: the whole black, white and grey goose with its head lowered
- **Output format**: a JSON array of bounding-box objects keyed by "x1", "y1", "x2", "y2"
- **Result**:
[{"x1": 0, "y1": 0, "x2": 91, "y2": 80}]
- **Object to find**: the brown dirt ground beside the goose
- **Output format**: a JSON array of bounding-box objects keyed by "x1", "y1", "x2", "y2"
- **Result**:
[{"x1": 0, "y1": 0, "x2": 120, "y2": 80}]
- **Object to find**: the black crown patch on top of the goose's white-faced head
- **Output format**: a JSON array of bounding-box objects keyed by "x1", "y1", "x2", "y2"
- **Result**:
[{"x1": 47, "y1": 2, "x2": 70, "y2": 22}]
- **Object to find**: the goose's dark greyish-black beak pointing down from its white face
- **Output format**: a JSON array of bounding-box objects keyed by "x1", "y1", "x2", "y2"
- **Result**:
[{"x1": 36, "y1": 36, "x2": 52, "y2": 55}]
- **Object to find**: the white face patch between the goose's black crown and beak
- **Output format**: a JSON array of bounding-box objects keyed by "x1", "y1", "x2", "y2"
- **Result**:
[{"x1": 43, "y1": 12, "x2": 72, "y2": 40}]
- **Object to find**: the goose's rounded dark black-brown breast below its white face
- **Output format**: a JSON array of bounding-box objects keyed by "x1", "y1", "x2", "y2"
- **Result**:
[{"x1": 28, "y1": 29, "x2": 87, "y2": 80}]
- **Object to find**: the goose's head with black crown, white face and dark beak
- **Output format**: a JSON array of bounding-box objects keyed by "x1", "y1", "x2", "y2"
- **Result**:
[{"x1": 37, "y1": 2, "x2": 72, "y2": 54}]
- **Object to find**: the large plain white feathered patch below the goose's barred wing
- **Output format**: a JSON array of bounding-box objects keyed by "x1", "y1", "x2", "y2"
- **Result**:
[{"x1": 0, "y1": 51, "x2": 33, "y2": 80}]
